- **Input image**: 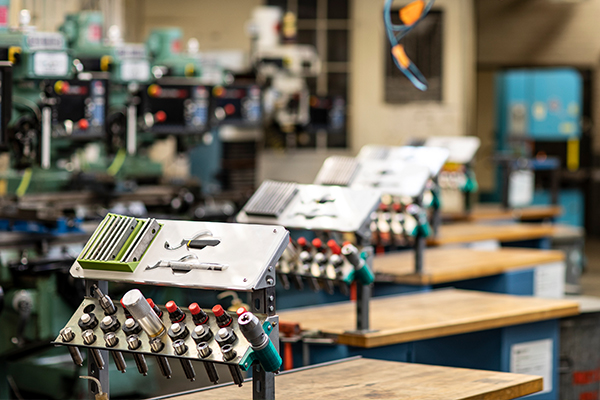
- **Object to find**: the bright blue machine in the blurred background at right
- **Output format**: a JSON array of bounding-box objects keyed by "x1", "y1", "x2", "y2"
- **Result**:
[{"x1": 495, "y1": 68, "x2": 584, "y2": 226}]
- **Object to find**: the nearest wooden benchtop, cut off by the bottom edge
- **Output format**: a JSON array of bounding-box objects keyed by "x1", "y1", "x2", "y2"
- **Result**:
[{"x1": 170, "y1": 358, "x2": 543, "y2": 400}]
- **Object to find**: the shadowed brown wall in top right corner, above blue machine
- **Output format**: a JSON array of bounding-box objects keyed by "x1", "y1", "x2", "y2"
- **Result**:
[{"x1": 476, "y1": 0, "x2": 600, "y2": 65}]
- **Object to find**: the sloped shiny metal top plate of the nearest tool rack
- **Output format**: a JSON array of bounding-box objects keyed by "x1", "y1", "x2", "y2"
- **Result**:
[{"x1": 70, "y1": 220, "x2": 289, "y2": 291}]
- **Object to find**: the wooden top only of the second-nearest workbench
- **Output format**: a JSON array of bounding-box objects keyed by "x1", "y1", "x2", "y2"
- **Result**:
[{"x1": 279, "y1": 289, "x2": 579, "y2": 347}]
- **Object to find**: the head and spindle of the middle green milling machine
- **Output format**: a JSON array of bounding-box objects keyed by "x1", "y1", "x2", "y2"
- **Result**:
[{"x1": 59, "y1": 10, "x2": 163, "y2": 182}]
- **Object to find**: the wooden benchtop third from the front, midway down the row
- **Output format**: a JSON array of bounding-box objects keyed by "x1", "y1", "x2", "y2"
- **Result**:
[{"x1": 373, "y1": 247, "x2": 565, "y2": 285}]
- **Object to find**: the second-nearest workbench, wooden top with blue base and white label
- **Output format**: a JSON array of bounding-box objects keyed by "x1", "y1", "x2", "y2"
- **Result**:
[{"x1": 280, "y1": 289, "x2": 579, "y2": 400}]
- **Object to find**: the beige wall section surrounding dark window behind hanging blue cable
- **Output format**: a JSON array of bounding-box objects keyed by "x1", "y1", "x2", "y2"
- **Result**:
[{"x1": 350, "y1": 0, "x2": 475, "y2": 152}]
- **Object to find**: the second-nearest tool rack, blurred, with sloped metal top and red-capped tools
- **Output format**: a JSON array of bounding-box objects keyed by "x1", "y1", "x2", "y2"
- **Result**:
[{"x1": 236, "y1": 181, "x2": 380, "y2": 331}]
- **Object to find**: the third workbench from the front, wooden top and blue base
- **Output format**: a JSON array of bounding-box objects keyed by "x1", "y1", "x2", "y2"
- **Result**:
[{"x1": 373, "y1": 247, "x2": 565, "y2": 297}]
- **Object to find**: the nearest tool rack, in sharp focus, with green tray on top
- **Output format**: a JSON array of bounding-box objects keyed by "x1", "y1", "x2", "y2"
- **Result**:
[{"x1": 53, "y1": 214, "x2": 289, "y2": 399}]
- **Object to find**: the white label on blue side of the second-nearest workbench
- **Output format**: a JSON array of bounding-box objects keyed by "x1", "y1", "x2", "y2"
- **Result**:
[{"x1": 510, "y1": 339, "x2": 553, "y2": 393}]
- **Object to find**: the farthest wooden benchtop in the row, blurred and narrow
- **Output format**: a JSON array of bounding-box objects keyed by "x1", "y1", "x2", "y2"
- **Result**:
[{"x1": 442, "y1": 204, "x2": 562, "y2": 221}]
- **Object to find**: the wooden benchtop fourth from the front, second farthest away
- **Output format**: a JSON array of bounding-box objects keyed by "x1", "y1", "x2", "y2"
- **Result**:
[{"x1": 427, "y1": 222, "x2": 554, "y2": 246}]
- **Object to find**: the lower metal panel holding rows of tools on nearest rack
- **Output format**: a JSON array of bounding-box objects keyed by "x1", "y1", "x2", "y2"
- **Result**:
[{"x1": 53, "y1": 297, "x2": 266, "y2": 369}]
